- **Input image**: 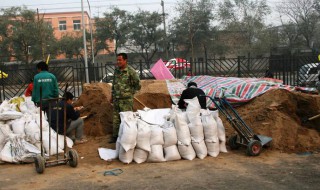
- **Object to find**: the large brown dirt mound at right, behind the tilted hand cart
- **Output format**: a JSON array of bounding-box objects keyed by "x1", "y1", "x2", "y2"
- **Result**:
[{"x1": 230, "y1": 89, "x2": 320, "y2": 152}]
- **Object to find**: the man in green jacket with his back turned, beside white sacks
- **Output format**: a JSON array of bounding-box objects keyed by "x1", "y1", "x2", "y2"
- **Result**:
[{"x1": 32, "y1": 61, "x2": 59, "y2": 112}]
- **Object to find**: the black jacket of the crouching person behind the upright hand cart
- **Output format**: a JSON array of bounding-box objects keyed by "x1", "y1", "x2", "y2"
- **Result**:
[{"x1": 49, "y1": 100, "x2": 80, "y2": 134}]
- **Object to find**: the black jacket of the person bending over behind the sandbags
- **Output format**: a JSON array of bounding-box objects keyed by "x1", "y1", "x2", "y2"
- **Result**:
[{"x1": 178, "y1": 87, "x2": 207, "y2": 109}]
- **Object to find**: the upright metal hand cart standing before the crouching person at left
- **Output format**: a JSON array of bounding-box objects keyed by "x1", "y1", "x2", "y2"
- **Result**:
[{"x1": 34, "y1": 87, "x2": 79, "y2": 174}]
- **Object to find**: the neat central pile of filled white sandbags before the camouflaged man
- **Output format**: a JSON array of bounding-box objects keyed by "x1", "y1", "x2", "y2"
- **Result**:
[{"x1": 116, "y1": 97, "x2": 227, "y2": 164}]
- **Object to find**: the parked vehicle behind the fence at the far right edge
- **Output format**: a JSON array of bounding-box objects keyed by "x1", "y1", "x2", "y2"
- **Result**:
[{"x1": 297, "y1": 63, "x2": 320, "y2": 87}]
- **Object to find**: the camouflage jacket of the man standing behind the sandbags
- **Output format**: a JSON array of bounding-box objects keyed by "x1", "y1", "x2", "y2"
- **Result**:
[{"x1": 112, "y1": 65, "x2": 141, "y2": 100}]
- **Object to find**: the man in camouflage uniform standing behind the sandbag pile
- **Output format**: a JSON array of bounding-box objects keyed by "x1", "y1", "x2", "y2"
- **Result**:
[{"x1": 109, "y1": 53, "x2": 141, "y2": 143}]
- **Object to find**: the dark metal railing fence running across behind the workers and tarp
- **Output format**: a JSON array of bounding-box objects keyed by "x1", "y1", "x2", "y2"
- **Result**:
[{"x1": 0, "y1": 56, "x2": 319, "y2": 101}]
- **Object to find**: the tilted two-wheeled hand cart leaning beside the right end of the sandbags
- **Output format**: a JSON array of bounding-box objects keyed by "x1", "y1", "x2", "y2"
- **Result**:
[{"x1": 206, "y1": 96, "x2": 272, "y2": 156}]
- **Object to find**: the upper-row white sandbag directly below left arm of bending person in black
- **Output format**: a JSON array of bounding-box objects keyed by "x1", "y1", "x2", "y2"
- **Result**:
[{"x1": 175, "y1": 112, "x2": 191, "y2": 146}]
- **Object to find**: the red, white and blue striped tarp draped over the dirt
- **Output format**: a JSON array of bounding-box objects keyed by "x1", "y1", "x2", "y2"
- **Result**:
[{"x1": 167, "y1": 75, "x2": 315, "y2": 106}]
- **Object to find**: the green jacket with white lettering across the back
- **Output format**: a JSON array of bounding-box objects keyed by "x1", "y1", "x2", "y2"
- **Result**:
[{"x1": 32, "y1": 71, "x2": 59, "y2": 103}]
